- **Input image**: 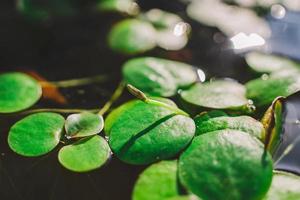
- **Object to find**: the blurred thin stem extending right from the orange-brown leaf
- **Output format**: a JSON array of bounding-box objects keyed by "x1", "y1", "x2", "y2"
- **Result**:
[{"x1": 40, "y1": 75, "x2": 108, "y2": 88}]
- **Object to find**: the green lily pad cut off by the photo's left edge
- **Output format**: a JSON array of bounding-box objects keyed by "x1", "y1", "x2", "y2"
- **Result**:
[{"x1": 0, "y1": 72, "x2": 42, "y2": 113}]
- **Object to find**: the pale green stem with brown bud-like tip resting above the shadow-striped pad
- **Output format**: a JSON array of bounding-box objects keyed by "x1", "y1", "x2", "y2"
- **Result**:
[{"x1": 127, "y1": 84, "x2": 189, "y2": 117}]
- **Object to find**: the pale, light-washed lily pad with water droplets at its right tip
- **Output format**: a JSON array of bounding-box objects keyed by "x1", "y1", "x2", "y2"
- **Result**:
[{"x1": 180, "y1": 80, "x2": 253, "y2": 112}]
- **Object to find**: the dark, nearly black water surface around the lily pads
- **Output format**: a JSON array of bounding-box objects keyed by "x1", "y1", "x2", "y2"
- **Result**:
[{"x1": 0, "y1": 0, "x2": 298, "y2": 200}]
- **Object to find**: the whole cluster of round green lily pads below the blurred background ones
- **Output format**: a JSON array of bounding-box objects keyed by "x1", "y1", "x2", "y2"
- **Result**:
[{"x1": 0, "y1": 52, "x2": 300, "y2": 200}]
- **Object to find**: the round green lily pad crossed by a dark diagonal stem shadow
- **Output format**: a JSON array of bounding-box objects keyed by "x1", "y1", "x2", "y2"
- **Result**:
[{"x1": 107, "y1": 100, "x2": 195, "y2": 164}]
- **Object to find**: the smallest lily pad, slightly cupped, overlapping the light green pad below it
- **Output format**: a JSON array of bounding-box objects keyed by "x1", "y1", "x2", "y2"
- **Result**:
[{"x1": 65, "y1": 112, "x2": 104, "y2": 138}]
